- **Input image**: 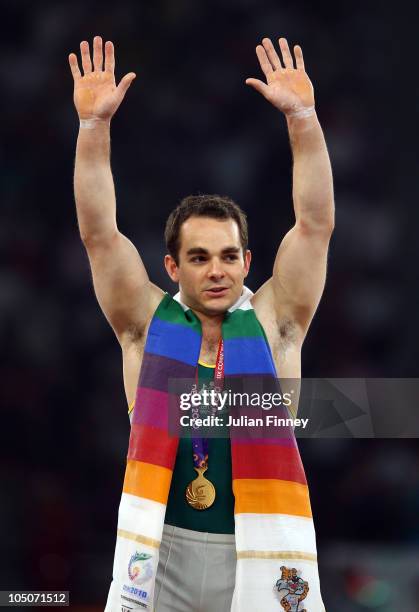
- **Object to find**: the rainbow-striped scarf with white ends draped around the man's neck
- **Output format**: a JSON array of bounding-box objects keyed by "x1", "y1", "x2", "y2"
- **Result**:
[{"x1": 105, "y1": 287, "x2": 324, "y2": 612}]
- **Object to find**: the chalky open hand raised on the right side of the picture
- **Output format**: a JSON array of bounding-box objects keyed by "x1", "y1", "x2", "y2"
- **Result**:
[{"x1": 246, "y1": 38, "x2": 314, "y2": 115}]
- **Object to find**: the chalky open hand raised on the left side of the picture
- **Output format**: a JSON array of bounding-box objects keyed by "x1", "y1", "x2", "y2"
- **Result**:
[{"x1": 68, "y1": 36, "x2": 136, "y2": 121}]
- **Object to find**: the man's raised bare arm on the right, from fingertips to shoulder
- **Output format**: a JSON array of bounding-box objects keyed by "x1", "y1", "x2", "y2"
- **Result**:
[{"x1": 246, "y1": 38, "x2": 334, "y2": 340}]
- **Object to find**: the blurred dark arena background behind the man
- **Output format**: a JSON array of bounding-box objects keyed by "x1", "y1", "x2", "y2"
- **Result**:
[{"x1": 0, "y1": 0, "x2": 419, "y2": 612}]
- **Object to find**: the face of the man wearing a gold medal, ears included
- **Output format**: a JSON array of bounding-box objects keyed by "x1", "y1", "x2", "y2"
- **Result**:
[{"x1": 165, "y1": 217, "x2": 251, "y2": 315}]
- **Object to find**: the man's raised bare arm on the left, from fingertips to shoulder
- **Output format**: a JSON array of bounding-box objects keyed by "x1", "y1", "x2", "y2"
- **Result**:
[{"x1": 69, "y1": 36, "x2": 163, "y2": 345}]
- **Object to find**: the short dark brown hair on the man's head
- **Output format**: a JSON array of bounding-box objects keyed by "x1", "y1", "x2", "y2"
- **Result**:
[{"x1": 164, "y1": 194, "x2": 248, "y2": 264}]
